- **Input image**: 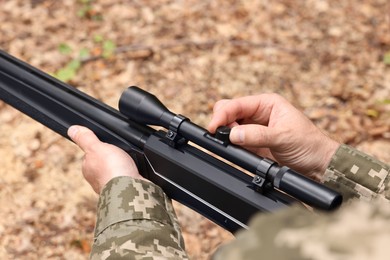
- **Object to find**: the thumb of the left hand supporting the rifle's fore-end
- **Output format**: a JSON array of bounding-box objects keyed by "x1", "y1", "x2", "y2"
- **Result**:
[{"x1": 68, "y1": 125, "x2": 100, "y2": 152}]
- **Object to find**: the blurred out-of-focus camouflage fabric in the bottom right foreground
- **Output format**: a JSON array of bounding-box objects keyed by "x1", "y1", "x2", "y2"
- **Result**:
[{"x1": 213, "y1": 199, "x2": 390, "y2": 260}]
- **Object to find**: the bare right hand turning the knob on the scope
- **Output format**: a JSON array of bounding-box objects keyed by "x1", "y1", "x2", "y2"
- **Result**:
[{"x1": 208, "y1": 94, "x2": 339, "y2": 177}]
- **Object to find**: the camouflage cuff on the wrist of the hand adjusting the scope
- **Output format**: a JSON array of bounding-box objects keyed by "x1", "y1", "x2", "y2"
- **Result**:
[{"x1": 323, "y1": 145, "x2": 390, "y2": 201}]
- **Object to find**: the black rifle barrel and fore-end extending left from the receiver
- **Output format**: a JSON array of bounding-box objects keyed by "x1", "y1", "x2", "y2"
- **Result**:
[{"x1": 0, "y1": 50, "x2": 154, "y2": 152}]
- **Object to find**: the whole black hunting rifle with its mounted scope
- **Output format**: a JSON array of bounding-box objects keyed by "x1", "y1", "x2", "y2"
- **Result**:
[{"x1": 0, "y1": 50, "x2": 342, "y2": 232}]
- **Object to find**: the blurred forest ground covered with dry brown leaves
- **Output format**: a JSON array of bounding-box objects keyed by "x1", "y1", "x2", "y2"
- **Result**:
[{"x1": 0, "y1": 0, "x2": 390, "y2": 259}]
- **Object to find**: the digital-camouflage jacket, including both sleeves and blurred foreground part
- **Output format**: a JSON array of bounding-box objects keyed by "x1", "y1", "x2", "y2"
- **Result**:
[{"x1": 91, "y1": 145, "x2": 390, "y2": 260}]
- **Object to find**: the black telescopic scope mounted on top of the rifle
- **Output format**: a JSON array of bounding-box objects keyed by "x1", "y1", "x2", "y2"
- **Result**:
[{"x1": 119, "y1": 86, "x2": 342, "y2": 210}]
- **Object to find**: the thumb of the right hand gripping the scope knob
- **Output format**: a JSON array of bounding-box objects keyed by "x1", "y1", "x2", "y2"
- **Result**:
[{"x1": 230, "y1": 125, "x2": 276, "y2": 147}]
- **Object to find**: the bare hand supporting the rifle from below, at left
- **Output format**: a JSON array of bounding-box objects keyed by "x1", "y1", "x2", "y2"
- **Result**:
[{"x1": 68, "y1": 126, "x2": 142, "y2": 194}]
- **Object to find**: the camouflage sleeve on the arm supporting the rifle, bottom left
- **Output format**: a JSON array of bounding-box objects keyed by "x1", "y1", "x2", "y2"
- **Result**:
[{"x1": 91, "y1": 176, "x2": 187, "y2": 260}]
